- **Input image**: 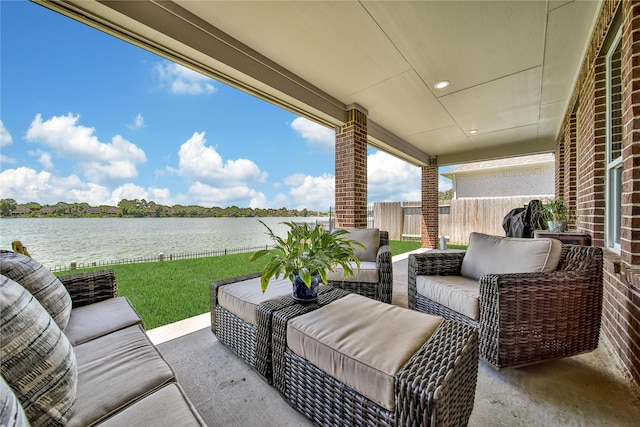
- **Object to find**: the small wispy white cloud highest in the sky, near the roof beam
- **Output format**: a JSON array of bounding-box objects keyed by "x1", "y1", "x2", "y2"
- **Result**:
[{"x1": 153, "y1": 61, "x2": 216, "y2": 95}]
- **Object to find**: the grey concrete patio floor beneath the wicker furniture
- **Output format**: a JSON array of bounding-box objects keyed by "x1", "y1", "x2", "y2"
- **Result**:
[{"x1": 148, "y1": 254, "x2": 640, "y2": 427}]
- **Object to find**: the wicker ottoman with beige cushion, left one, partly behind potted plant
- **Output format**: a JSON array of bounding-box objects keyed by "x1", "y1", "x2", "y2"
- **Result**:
[{"x1": 210, "y1": 273, "x2": 332, "y2": 383}]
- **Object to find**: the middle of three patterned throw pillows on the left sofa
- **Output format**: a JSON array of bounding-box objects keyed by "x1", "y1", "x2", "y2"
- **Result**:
[{"x1": 0, "y1": 276, "x2": 78, "y2": 427}]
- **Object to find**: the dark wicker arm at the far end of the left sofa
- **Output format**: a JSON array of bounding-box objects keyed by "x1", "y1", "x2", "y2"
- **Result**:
[{"x1": 59, "y1": 270, "x2": 118, "y2": 308}]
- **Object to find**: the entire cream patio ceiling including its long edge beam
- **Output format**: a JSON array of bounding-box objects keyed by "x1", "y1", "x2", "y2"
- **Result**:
[{"x1": 35, "y1": 0, "x2": 601, "y2": 165}]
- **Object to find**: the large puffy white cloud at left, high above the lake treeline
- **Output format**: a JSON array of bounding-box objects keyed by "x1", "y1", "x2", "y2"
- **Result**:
[{"x1": 26, "y1": 113, "x2": 147, "y2": 183}]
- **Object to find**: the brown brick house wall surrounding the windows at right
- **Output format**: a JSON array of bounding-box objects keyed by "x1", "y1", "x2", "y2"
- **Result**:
[{"x1": 556, "y1": 0, "x2": 640, "y2": 385}]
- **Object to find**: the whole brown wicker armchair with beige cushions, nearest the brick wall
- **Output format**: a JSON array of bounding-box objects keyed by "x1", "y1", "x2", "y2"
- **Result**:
[{"x1": 408, "y1": 233, "x2": 603, "y2": 369}]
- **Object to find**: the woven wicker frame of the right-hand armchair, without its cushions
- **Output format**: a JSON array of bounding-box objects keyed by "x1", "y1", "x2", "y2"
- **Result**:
[{"x1": 408, "y1": 245, "x2": 603, "y2": 369}]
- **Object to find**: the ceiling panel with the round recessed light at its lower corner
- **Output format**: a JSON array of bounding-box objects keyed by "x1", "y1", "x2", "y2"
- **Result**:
[{"x1": 364, "y1": 1, "x2": 547, "y2": 94}]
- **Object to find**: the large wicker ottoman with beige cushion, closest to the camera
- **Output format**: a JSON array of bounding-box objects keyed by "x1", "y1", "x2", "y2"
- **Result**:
[{"x1": 272, "y1": 294, "x2": 478, "y2": 426}]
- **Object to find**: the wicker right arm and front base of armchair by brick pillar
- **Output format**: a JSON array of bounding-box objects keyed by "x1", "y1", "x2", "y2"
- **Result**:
[{"x1": 327, "y1": 230, "x2": 393, "y2": 304}]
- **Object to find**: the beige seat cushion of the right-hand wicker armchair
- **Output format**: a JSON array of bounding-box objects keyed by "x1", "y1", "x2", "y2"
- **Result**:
[{"x1": 416, "y1": 276, "x2": 480, "y2": 320}]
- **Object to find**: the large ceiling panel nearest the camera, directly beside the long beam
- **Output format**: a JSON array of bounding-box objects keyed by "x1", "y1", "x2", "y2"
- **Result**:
[{"x1": 178, "y1": 1, "x2": 409, "y2": 98}]
